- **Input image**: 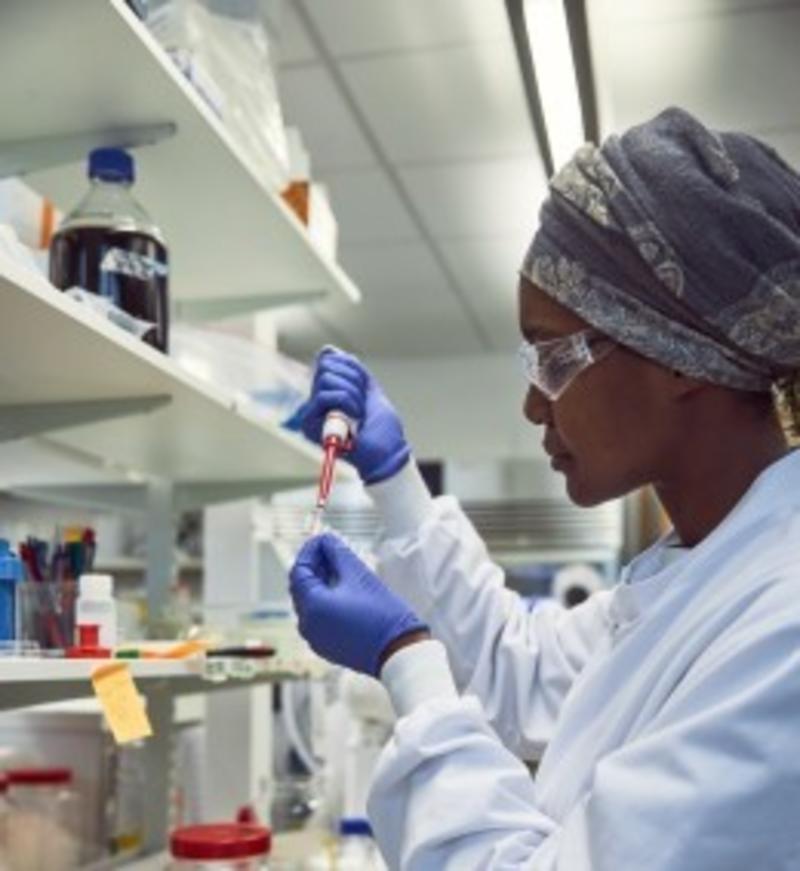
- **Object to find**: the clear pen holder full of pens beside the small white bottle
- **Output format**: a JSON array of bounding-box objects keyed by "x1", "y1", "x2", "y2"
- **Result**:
[{"x1": 17, "y1": 581, "x2": 78, "y2": 651}]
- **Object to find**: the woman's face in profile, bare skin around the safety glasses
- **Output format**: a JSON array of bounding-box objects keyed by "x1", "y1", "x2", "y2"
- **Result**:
[{"x1": 519, "y1": 279, "x2": 679, "y2": 506}]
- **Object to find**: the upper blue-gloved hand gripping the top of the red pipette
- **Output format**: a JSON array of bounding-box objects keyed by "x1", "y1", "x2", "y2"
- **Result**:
[{"x1": 302, "y1": 348, "x2": 411, "y2": 484}]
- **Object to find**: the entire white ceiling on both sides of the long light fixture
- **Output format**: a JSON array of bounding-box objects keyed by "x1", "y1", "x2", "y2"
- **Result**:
[{"x1": 279, "y1": 0, "x2": 800, "y2": 358}]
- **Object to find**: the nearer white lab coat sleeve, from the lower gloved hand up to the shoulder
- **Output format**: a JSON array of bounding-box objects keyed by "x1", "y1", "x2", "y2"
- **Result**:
[{"x1": 369, "y1": 585, "x2": 800, "y2": 871}]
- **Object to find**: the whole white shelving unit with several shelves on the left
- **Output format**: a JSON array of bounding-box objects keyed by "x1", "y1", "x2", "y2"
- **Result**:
[{"x1": 0, "y1": 0, "x2": 359, "y2": 854}]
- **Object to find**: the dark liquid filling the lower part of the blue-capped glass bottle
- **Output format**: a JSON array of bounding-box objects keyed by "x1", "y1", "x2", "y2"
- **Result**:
[{"x1": 50, "y1": 227, "x2": 169, "y2": 353}]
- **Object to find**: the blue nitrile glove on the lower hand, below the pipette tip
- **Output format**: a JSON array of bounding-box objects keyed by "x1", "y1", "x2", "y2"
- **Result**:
[{"x1": 289, "y1": 532, "x2": 427, "y2": 677}]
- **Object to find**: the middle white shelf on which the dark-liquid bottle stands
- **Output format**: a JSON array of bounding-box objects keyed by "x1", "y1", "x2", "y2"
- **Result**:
[{"x1": 0, "y1": 265, "x2": 348, "y2": 486}]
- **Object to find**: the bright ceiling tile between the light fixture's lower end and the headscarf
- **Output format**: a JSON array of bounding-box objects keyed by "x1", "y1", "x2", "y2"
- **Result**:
[{"x1": 400, "y1": 156, "x2": 547, "y2": 238}]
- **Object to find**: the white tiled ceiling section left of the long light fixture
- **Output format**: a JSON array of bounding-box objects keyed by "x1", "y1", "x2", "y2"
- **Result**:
[{"x1": 272, "y1": 0, "x2": 545, "y2": 358}]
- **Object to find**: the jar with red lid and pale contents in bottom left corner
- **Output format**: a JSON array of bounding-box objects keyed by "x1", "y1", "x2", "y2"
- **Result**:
[{"x1": 7, "y1": 768, "x2": 82, "y2": 871}]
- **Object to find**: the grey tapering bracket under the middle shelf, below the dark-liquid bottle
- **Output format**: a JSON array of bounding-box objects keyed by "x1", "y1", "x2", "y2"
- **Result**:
[{"x1": 0, "y1": 396, "x2": 172, "y2": 442}]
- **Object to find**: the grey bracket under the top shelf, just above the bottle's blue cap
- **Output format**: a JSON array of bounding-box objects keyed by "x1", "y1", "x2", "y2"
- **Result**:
[{"x1": 0, "y1": 122, "x2": 178, "y2": 178}]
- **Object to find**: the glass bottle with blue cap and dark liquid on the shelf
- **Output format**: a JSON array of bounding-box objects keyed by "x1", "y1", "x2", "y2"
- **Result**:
[{"x1": 50, "y1": 148, "x2": 169, "y2": 352}]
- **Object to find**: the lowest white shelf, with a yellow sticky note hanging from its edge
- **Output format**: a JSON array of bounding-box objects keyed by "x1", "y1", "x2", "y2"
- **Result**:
[{"x1": 0, "y1": 657, "x2": 322, "y2": 710}]
